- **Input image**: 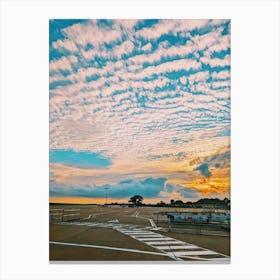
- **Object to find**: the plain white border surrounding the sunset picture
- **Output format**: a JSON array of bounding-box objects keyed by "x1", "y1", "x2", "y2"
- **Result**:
[{"x1": 0, "y1": 0, "x2": 280, "y2": 280}]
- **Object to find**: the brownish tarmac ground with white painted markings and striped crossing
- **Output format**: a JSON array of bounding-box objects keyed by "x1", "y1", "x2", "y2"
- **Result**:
[{"x1": 49, "y1": 205, "x2": 230, "y2": 262}]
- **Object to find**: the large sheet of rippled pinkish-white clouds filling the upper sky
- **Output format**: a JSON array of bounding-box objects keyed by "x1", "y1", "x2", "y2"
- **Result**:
[{"x1": 50, "y1": 20, "x2": 230, "y2": 197}]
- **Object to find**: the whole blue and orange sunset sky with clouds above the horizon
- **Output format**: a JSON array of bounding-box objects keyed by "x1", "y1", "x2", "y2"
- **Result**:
[{"x1": 49, "y1": 19, "x2": 230, "y2": 203}]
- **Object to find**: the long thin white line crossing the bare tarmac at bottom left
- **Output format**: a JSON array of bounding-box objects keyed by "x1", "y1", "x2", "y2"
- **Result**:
[{"x1": 49, "y1": 241, "x2": 174, "y2": 259}]
